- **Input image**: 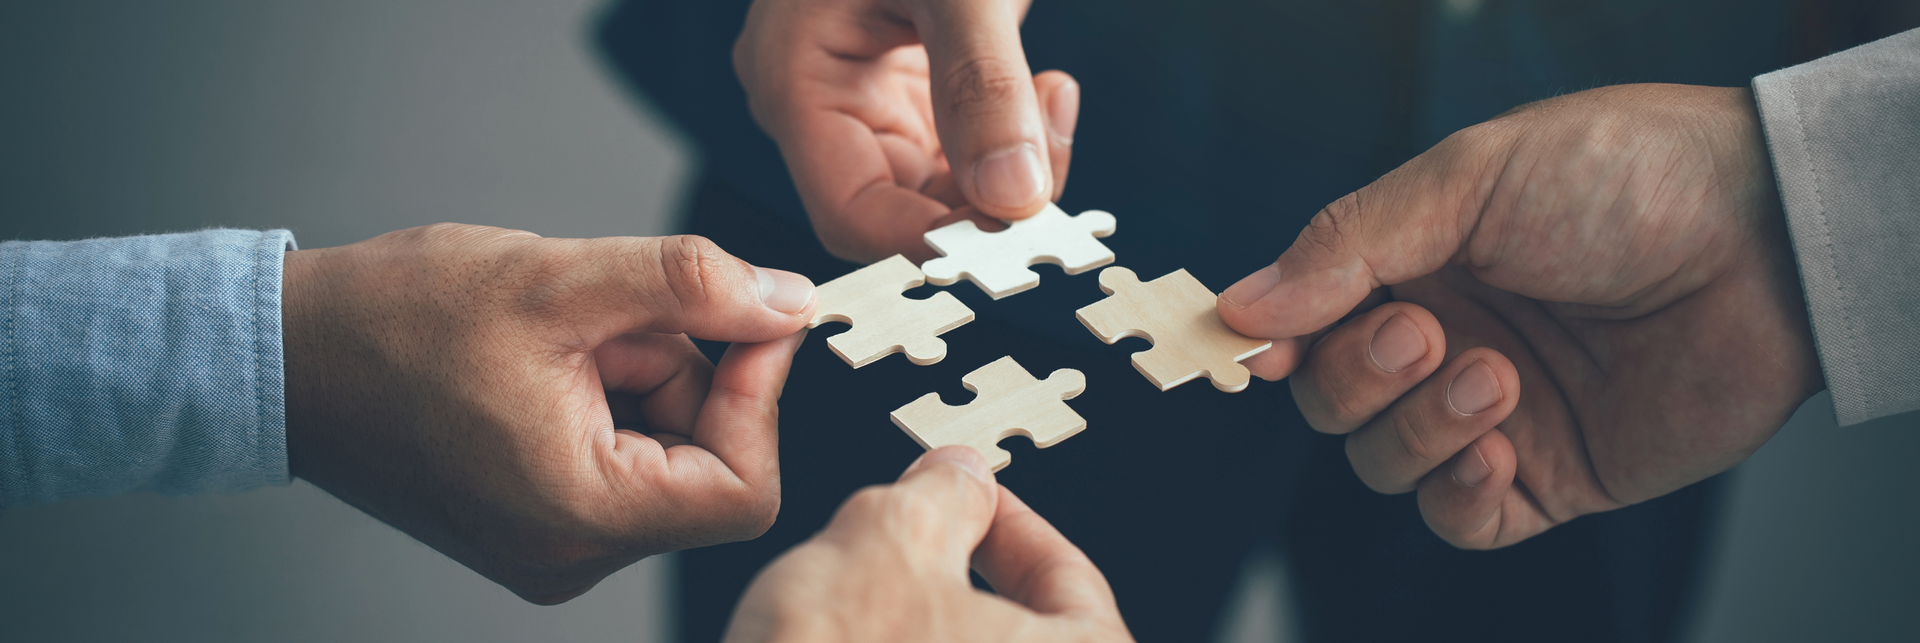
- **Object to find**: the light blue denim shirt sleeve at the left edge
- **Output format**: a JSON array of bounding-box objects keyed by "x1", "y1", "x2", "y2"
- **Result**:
[{"x1": 0, "y1": 230, "x2": 294, "y2": 507}]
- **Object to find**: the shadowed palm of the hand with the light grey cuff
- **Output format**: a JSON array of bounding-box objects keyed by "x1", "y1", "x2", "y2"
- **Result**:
[{"x1": 1390, "y1": 85, "x2": 1818, "y2": 545}]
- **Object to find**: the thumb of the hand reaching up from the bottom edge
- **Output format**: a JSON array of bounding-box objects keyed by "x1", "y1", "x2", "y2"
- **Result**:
[{"x1": 828, "y1": 447, "x2": 998, "y2": 585}]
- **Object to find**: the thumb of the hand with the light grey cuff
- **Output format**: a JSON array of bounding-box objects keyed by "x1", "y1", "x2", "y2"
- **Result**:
[{"x1": 1217, "y1": 132, "x2": 1500, "y2": 340}]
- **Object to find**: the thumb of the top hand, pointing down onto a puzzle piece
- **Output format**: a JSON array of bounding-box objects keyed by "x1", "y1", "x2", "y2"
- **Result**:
[{"x1": 910, "y1": 0, "x2": 1052, "y2": 219}]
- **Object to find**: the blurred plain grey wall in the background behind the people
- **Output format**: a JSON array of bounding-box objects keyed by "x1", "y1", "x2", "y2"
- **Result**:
[{"x1": 0, "y1": 0, "x2": 1920, "y2": 643}]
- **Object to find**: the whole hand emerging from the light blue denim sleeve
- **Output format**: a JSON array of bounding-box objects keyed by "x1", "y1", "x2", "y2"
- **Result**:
[{"x1": 282, "y1": 225, "x2": 814, "y2": 603}]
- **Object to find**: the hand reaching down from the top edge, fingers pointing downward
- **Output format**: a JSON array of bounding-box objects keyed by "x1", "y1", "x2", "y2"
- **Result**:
[{"x1": 733, "y1": 0, "x2": 1079, "y2": 263}]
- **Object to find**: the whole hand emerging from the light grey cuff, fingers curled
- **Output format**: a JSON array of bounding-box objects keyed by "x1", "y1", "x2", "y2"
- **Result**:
[{"x1": 1219, "y1": 84, "x2": 1824, "y2": 547}]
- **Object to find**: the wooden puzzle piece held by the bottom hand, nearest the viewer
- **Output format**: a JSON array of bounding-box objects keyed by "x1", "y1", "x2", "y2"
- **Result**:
[{"x1": 889, "y1": 357, "x2": 1087, "y2": 470}]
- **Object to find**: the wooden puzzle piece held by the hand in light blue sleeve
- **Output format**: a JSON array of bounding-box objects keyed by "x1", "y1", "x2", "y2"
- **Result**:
[{"x1": 806, "y1": 255, "x2": 973, "y2": 369}]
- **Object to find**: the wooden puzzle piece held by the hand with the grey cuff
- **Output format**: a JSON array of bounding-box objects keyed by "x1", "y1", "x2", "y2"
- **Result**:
[{"x1": 1073, "y1": 267, "x2": 1273, "y2": 393}]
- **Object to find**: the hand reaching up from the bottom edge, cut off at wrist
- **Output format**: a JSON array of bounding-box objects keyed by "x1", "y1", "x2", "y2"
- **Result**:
[{"x1": 726, "y1": 447, "x2": 1133, "y2": 643}]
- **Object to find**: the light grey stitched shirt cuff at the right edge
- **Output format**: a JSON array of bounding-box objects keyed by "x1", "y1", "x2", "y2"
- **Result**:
[{"x1": 1753, "y1": 29, "x2": 1920, "y2": 426}]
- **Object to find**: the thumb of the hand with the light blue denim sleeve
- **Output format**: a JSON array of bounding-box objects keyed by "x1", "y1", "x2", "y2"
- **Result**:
[{"x1": 574, "y1": 234, "x2": 814, "y2": 344}]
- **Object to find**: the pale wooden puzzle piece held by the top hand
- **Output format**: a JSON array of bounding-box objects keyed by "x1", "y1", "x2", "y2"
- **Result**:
[{"x1": 920, "y1": 203, "x2": 1114, "y2": 299}]
